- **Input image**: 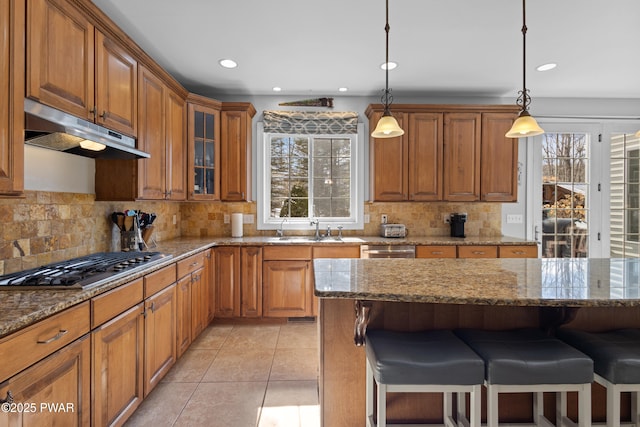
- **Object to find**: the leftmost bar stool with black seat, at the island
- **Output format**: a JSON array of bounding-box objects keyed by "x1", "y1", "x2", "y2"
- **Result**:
[{"x1": 365, "y1": 330, "x2": 484, "y2": 427}]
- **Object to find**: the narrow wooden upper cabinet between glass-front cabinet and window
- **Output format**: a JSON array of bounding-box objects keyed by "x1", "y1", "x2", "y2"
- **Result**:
[{"x1": 220, "y1": 102, "x2": 256, "y2": 202}]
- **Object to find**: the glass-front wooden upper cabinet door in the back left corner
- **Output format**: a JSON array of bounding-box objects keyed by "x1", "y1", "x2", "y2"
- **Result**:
[{"x1": 189, "y1": 98, "x2": 220, "y2": 200}]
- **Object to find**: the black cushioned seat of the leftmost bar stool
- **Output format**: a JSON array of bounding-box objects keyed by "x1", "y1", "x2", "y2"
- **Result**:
[{"x1": 366, "y1": 330, "x2": 484, "y2": 385}]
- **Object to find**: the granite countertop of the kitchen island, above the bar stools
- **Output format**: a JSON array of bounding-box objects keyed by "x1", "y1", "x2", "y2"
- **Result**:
[{"x1": 314, "y1": 258, "x2": 640, "y2": 307}]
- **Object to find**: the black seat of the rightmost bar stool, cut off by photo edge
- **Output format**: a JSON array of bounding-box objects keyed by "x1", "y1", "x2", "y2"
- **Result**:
[{"x1": 557, "y1": 329, "x2": 640, "y2": 384}]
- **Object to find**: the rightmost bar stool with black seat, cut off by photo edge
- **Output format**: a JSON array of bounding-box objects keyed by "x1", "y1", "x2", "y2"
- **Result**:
[{"x1": 557, "y1": 328, "x2": 640, "y2": 427}]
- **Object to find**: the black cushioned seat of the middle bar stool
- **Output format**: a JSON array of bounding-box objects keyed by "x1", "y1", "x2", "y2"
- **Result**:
[{"x1": 455, "y1": 329, "x2": 593, "y2": 385}]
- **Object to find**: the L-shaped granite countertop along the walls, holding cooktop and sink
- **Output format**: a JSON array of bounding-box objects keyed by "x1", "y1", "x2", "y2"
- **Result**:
[{"x1": 0, "y1": 236, "x2": 536, "y2": 337}]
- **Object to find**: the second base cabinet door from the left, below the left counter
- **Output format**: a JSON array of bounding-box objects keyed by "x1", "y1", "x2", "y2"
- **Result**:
[{"x1": 91, "y1": 304, "x2": 144, "y2": 426}]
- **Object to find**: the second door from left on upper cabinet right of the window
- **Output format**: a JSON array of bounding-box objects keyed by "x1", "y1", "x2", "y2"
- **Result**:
[{"x1": 408, "y1": 113, "x2": 443, "y2": 201}]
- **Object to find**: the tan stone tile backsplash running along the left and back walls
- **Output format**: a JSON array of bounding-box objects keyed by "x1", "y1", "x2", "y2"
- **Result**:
[{"x1": 0, "y1": 191, "x2": 502, "y2": 274}]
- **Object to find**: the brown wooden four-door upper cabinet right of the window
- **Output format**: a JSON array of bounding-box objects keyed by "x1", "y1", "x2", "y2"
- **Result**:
[{"x1": 365, "y1": 104, "x2": 518, "y2": 202}]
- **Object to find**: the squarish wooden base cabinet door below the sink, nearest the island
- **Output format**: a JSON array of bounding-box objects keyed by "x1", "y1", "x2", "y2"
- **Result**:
[{"x1": 263, "y1": 261, "x2": 313, "y2": 317}]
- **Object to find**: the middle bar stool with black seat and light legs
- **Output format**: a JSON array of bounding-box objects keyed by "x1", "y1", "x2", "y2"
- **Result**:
[{"x1": 455, "y1": 329, "x2": 593, "y2": 427}]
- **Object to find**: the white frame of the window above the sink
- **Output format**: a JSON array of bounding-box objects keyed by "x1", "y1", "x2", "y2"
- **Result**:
[{"x1": 256, "y1": 122, "x2": 365, "y2": 230}]
